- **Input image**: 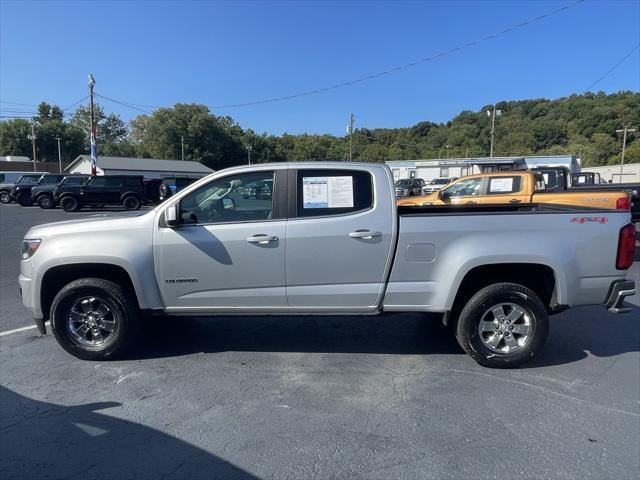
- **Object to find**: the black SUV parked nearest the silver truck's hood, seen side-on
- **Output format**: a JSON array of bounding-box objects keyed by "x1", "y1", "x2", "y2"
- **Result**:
[{"x1": 53, "y1": 175, "x2": 146, "y2": 212}]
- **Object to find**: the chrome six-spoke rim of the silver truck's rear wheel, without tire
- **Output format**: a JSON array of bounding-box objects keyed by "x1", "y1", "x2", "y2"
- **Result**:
[{"x1": 478, "y1": 302, "x2": 534, "y2": 353}]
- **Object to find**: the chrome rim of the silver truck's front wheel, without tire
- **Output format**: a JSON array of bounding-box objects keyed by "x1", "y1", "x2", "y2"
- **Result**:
[{"x1": 67, "y1": 297, "x2": 118, "y2": 347}]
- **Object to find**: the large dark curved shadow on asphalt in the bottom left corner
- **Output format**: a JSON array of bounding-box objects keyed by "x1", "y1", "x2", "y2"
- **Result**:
[{"x1": 0, "y1": 387, "x2": 256, "y2": 480}]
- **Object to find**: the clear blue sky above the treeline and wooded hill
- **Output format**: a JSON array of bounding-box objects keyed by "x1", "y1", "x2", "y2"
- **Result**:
[{"x1": 0, "y1": 0, "x2": 640, "y2": 135}]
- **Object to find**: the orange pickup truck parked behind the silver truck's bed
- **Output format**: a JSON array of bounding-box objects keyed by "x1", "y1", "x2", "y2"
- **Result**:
[{"x1": 398, "y1": 171, "x2": 631, "y2": 210}]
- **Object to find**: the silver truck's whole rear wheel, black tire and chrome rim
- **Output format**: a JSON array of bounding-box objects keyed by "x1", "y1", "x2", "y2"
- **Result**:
[{"x1": 456, "y1": 283, "x2": 549, "y2": 368}]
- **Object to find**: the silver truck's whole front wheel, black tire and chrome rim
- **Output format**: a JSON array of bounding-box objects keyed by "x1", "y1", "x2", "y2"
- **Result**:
[{"x1": 50, "y1": 278, "x2": 140, "y2": 360}]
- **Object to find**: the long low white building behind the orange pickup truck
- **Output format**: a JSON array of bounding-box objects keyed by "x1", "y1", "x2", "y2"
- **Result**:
[{"x1": 385, "y1": 155, "x2": 580, "y2": 182}]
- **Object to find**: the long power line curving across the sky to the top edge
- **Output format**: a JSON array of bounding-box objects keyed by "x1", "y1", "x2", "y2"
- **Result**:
[{"x1": 212, "y1": 0, "x2": 585, "y2": 109}]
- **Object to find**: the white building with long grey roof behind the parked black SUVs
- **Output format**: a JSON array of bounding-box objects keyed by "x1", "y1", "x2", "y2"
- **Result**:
[{"x1": 65, "y1": 155, "x2": 213, "y2": 180}]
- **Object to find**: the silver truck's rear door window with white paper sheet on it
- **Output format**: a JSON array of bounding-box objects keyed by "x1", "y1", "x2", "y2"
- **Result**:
[{"x1": 296, "y1": 169, "x2": 373, "y2": 217}]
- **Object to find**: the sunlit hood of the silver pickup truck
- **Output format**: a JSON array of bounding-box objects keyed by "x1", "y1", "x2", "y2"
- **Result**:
[{"x1": 25, "y1": 210, "x2": 155, "y2": 238}]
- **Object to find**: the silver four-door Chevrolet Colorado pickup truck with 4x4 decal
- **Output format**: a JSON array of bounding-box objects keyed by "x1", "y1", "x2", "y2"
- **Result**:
[{"x1": 19, "y1": 162, "x2": 635, "y2": 368}]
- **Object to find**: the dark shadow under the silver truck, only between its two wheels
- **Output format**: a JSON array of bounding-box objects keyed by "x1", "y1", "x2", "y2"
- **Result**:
[{"x1": 136, "y1": 314, "x2": 462, "y2": 358}]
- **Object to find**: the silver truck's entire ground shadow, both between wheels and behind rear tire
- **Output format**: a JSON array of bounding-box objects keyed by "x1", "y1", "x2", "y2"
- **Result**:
[{"x1": 135, "y1": 304, "x2": 640, "y2": 368}]
